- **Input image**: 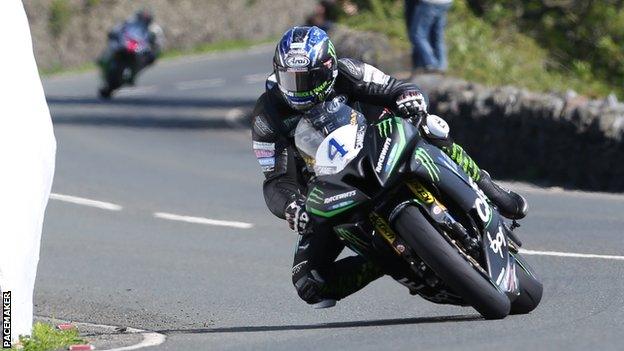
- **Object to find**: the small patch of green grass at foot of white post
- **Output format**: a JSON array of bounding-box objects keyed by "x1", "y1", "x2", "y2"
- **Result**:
[{"x1": 11, "y1": 323, "x2": 84, "y2": 351}]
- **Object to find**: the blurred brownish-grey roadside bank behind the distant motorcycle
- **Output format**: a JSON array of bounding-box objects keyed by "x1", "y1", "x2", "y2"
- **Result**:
[{"x1": 24, "y1": 0, "x2": 314, "y2": 70}]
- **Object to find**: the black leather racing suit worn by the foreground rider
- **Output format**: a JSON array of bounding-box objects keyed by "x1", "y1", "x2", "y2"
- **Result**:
[{"x1": 252, "y1": 58, "x2": 476, "y2": 303}]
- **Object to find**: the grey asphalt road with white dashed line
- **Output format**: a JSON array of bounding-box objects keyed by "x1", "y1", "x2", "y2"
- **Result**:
[{"x1": 35, "y1": 47, "x2": 624, "y2": 350}]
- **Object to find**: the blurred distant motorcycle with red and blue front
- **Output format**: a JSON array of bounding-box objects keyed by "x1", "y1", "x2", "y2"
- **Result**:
[{"x1": 99, "y1": 25, "x2": 154, "y2": 99}]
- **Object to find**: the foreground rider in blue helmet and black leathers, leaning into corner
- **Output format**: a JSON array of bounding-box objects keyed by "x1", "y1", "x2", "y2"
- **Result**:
[{"x1": 252, "y1": 27, "x2": 527, "y2": 308}]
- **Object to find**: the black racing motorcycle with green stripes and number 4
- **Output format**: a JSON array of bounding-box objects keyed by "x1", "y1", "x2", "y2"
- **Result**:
[{"x1": 294, "y1": 96, "x2": 542, "y2": 319}]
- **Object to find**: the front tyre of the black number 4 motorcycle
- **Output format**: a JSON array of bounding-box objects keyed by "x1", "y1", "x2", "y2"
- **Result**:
[{"x1": 394, "y1": 206, "x2": 511, "y2": 319}]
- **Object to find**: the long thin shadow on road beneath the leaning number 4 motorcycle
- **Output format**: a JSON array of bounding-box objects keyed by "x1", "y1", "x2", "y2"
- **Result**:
[{"x1": 156, "y1": 315, "x2": 483, "y2": 334}]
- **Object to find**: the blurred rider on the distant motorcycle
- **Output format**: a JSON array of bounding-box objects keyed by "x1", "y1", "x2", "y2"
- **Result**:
[{"x1": 98, "y1": 9, "x2": 165, "y2": 84}]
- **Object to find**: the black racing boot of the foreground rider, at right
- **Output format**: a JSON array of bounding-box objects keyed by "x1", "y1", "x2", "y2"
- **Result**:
[{"x1": 476, "y1": 170, "x2": 529, "y2": 220}]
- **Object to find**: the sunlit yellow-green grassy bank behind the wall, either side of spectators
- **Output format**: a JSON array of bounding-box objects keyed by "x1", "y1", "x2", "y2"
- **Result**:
[{"x1": 342, "y1": 0, "x2": 624, "y2": 96}]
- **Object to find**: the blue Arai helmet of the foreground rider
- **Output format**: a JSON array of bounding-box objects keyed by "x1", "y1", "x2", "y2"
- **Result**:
[{"x1": 273, "y1": 27, "x2": 338, "y2": 111}]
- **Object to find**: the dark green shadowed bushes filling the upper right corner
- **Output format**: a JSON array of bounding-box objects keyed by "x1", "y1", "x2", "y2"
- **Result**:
[{"x1": 469, "y1": 0, "x2": 624, "y2": 95}]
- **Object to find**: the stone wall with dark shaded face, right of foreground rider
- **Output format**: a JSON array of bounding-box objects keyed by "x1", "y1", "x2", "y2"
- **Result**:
[{"x1": 416, "y1": 76, "x2": 624, "y2": 192}]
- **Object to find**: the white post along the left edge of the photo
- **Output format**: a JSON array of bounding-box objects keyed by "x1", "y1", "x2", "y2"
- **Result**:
[{"x1": 0, "y1": 0, "x2": 56, "y2": 343}]
